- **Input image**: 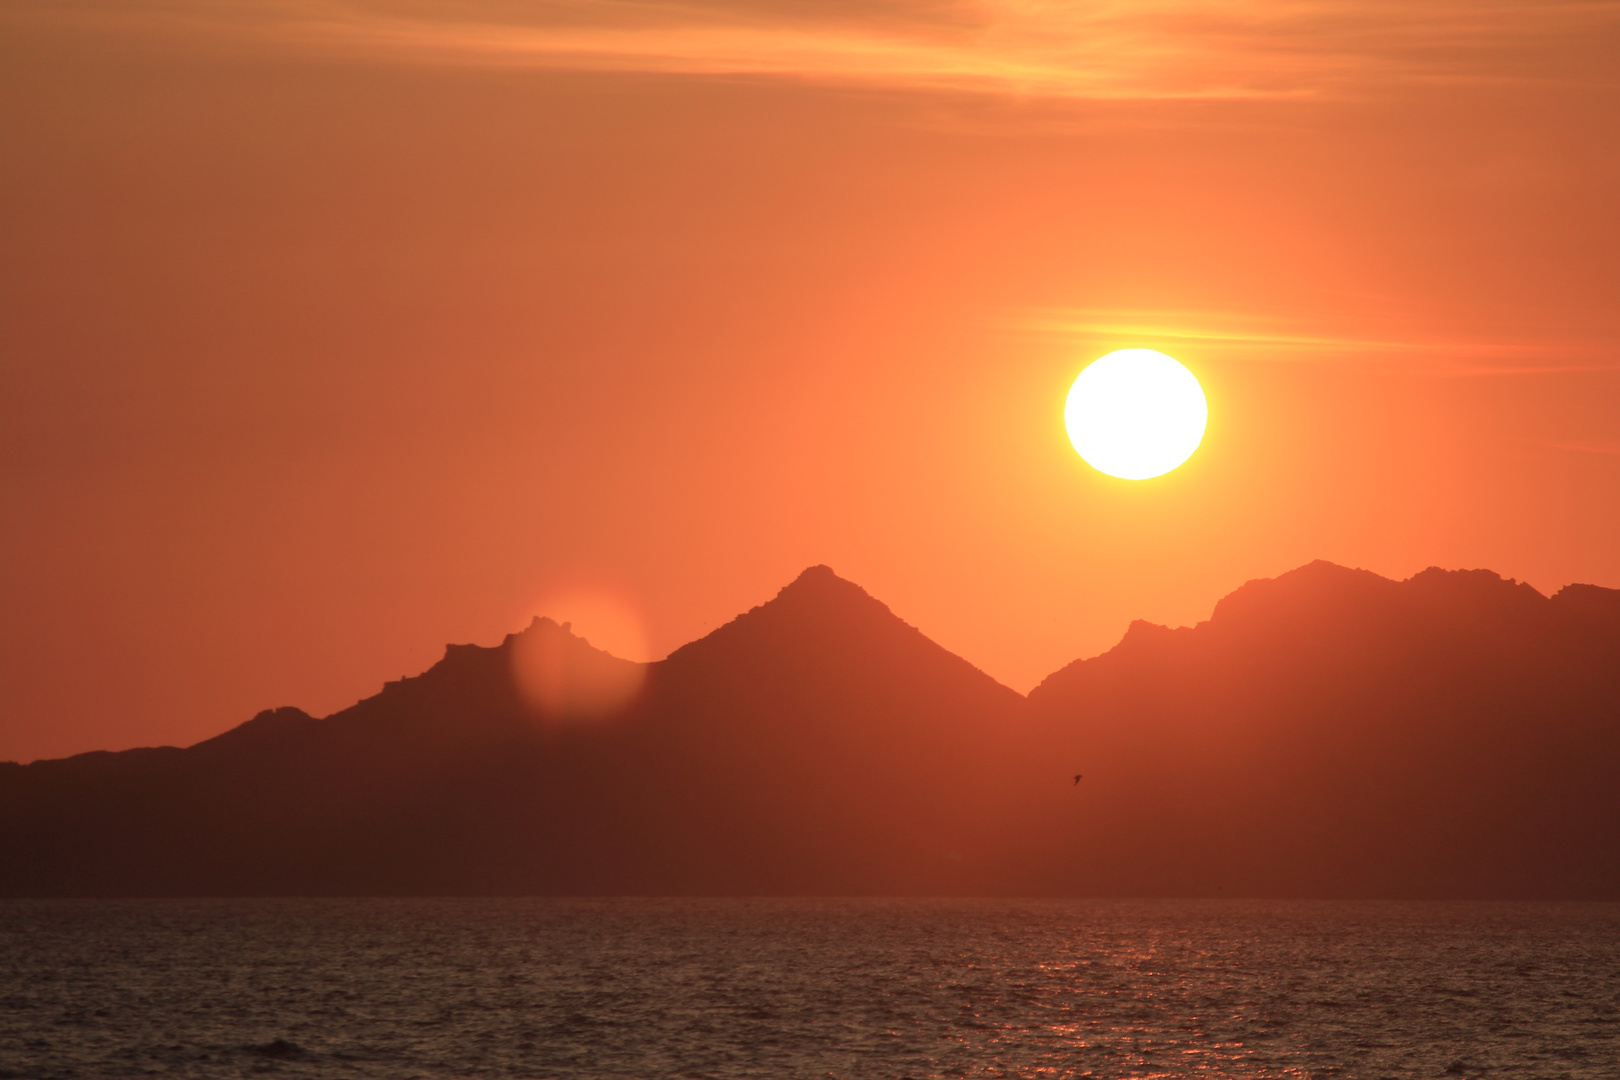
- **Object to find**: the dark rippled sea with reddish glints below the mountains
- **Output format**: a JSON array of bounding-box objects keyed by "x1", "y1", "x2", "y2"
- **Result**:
[{"x1": 0, "y1": 900, "x2": 1620, "y2": 1080}]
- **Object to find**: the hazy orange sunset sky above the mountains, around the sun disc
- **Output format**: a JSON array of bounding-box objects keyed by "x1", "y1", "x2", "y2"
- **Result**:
[{"x1": 0, "y1": 0, "x2": 1620, "y2": 761}]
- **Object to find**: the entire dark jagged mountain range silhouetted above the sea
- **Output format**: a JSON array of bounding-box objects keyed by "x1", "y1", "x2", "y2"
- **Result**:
[{"x1": 0, "y1": 562, "x2": 1620, "y2": 899}]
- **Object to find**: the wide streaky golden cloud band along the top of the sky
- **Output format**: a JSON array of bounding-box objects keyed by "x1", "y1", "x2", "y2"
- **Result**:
[{"x1": 22, "y1": 0, "x2": 1620, "y2": 99}]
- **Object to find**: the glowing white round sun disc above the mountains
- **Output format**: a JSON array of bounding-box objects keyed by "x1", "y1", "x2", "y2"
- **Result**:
[{"x1": 1063, "y1": 348, "x2": 1209, "y2": 479}]
